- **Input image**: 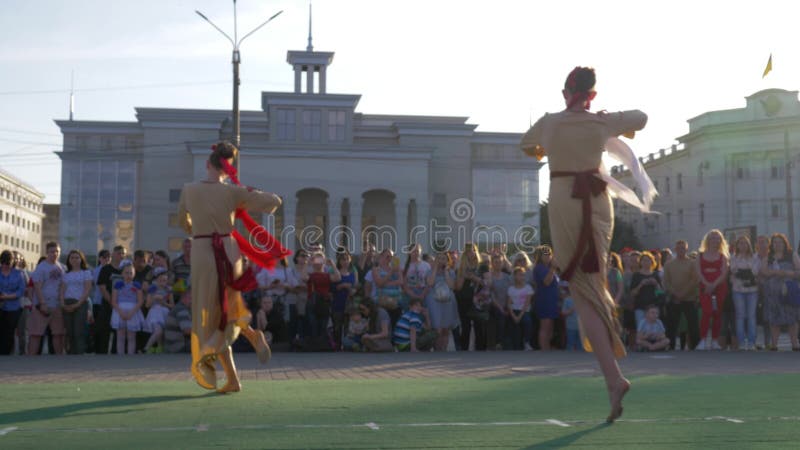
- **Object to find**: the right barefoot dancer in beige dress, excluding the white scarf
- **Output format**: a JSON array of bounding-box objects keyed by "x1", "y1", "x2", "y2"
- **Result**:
[{"x1": 521, "y1": 68, "x2": 647, "y2": 422}]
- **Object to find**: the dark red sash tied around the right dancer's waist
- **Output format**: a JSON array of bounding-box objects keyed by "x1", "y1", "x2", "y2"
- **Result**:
[{"x1": 550, "y1": 169, "x2": 607, "y2": 281}]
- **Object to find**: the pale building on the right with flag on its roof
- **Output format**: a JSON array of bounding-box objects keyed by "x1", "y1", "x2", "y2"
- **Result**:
[{"x1": 612, "y1": 89, "x2": 800, "y2": 248}]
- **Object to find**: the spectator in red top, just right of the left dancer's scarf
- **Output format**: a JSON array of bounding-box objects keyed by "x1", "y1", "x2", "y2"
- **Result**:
[{"x1": 306, "y1": 253, "x2": 342, "y2": 337}]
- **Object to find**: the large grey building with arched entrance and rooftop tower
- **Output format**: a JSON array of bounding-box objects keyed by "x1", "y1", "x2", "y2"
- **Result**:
[{"x1": 56, "y1": 46, "x2": 540, "y2": 260}]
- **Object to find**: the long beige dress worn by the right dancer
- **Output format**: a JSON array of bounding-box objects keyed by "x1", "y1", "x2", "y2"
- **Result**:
[{"x1": 521, "y1": 111, "x2": 647, "y2": 358}]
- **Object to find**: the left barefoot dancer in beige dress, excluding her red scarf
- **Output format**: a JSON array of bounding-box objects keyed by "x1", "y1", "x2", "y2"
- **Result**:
[{"x1": 178, "y1": 143, "x2": 281, "y2": 393}]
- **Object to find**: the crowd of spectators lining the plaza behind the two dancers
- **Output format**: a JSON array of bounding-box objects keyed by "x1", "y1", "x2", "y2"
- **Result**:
[{"x1": 0, "y1": 230, "x2": 800, "y2": 355}]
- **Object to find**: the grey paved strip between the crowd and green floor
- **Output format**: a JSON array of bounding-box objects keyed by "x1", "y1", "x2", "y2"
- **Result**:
[{"x1": 0, "y1": 351, "x2": 800, "y2": 383}]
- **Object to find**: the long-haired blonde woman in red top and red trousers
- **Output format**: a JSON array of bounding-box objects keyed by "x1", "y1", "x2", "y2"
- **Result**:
[{"x1": 695, "y1": 229, "x2": 729, "y2": 350}]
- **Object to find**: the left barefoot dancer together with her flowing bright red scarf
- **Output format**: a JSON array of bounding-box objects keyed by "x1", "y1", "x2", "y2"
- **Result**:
[{"x1": 178, "y1": 142, "x2": 290, "y2": 393}]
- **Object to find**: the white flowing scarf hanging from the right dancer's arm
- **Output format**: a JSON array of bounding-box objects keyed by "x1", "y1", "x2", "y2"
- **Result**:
[{"x1": 600, "y1": 137, "x2": 658, "y2": 213}]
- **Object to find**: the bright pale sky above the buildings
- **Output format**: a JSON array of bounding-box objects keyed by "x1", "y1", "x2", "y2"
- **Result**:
[{"x1": 0, "y1": 0, "x2": 800, "y2": 203}]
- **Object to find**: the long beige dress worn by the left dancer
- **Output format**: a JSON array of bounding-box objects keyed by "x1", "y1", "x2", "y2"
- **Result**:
[{"x1": 178, "y1": 182, "x2": 281, "y2": 376}]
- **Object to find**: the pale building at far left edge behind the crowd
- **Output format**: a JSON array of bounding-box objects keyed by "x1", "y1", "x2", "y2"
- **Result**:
[{"x1": 0, "y1": 169, "x2": 44, "y2": 268}]
